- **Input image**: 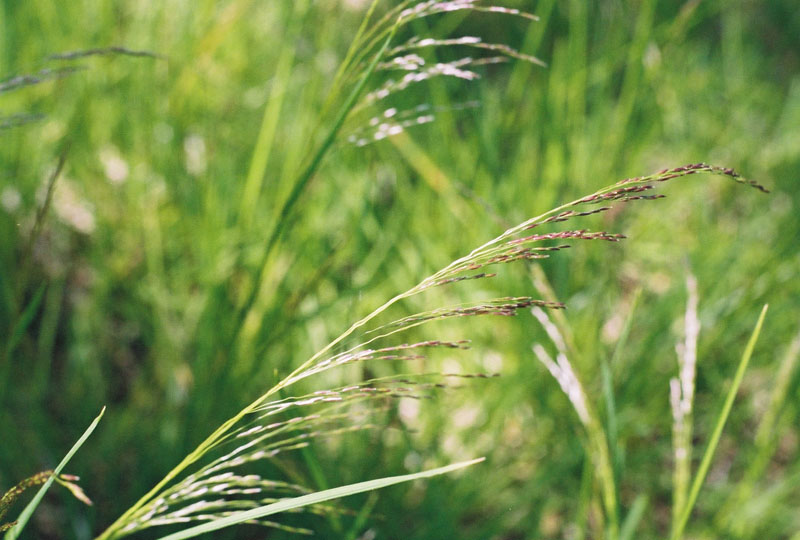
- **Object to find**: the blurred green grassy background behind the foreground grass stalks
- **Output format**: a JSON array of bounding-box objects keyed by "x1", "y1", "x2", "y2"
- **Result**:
[{"x1": 0, "y1": 0, "x2": 800, "y2": 540}]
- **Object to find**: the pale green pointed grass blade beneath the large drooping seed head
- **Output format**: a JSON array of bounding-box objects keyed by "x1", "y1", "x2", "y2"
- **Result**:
[{"x1": 155, "y1": 458, "x2": 485, "y2": 540}]
